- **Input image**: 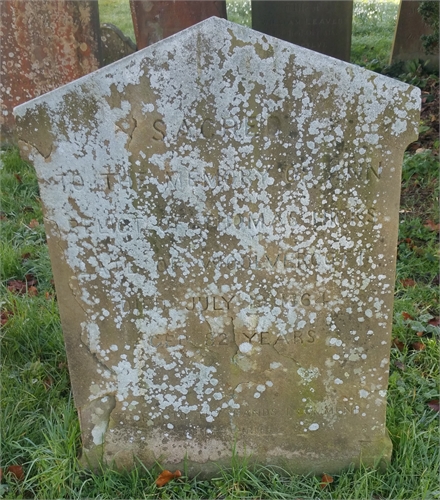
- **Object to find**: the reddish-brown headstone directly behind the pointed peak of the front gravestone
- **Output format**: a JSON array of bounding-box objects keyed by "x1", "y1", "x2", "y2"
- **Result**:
[{"x1": 130, "y1": 0, "x2": 226, "y2": 49}]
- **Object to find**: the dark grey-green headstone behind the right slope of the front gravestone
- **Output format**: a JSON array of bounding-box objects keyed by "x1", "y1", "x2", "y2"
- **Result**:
[{"x1": 252, "y1": 0, "x2": 353, "y2": 61}]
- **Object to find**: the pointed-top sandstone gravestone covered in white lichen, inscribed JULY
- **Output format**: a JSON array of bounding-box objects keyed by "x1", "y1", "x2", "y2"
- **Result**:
[{"x1": 15, "y1": 18, "x2": 420, "y2": 476}]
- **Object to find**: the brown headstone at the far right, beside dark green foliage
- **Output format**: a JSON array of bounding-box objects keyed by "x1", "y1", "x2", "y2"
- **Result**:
[{"x1": 390, "y1": 0, "x2": 440, "y2": 71}]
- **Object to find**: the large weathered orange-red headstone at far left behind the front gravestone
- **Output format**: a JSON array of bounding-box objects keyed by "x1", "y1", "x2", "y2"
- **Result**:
[{"x1": 0, "y1": 0, "x2": 99, "y2": 139}]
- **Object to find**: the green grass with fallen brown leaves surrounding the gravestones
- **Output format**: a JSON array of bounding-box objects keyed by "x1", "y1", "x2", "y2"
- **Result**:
[{"x1": 0, "y1": 0, "x2": 440, "y2": 500}]
